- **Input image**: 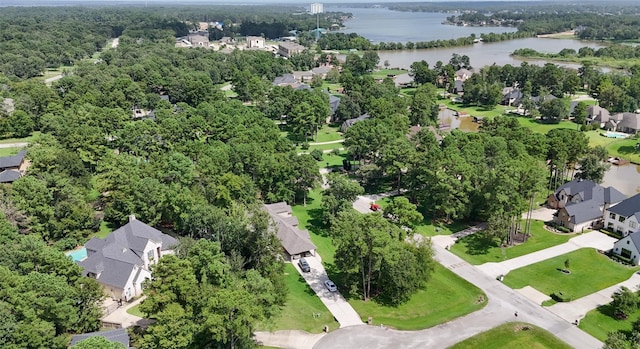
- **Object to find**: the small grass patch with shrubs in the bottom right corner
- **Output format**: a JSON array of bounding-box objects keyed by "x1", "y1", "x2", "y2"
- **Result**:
[{"x1": 578, "y1": 304, "x2": 640, "y2": 341}]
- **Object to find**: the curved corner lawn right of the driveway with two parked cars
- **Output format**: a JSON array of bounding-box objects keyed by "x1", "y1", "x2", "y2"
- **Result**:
[{"x1": 349, "y1": 263, "x2": 486, "y2": 330}]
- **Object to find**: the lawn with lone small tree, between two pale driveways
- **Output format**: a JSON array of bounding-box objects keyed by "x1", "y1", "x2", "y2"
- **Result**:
[{"x1": 504, "y1": 248, "x2": 638, "y2": 300}]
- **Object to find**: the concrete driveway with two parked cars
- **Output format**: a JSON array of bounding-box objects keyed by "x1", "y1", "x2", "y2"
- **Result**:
[{"x1": 293, "y1": 257, "x2": 362, "y2": 327}]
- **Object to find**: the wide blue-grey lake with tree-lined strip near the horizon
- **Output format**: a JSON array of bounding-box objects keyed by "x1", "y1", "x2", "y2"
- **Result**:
[{"x1": 327, "y1": 7, "x2": 606, "y2": 71}]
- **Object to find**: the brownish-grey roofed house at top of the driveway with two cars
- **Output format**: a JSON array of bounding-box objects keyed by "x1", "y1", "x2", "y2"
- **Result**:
[{"x1": 264, "y1": 202, "x2": 316, "y2": 260}]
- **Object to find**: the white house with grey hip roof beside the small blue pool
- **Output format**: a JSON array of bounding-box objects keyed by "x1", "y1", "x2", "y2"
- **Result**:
[{"x1": 78, "y1": 215, "x2": 177, "y2": 301}]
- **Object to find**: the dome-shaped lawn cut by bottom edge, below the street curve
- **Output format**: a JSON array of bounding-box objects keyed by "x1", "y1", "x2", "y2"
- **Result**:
[{"x1": 449, "y1": 322, "x2": 571, "y2": 349}]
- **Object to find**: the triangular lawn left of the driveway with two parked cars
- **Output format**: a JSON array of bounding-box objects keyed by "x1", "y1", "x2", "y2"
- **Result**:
[{"x1": 261, "y1": 263, "x2": 340, "y2": 333}]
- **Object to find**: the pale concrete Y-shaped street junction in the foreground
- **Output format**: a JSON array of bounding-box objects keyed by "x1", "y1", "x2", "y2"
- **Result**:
[{"x1": 314, "y1": 244, "x2": 602, "y2": 349}]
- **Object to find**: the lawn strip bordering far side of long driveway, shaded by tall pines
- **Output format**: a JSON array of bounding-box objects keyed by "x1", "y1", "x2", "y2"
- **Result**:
[{"x1": 450, "y1": 221, "x2": 575, "y2": 264}]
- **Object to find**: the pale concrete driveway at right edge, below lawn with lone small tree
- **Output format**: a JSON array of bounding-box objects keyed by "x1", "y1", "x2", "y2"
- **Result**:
[{"x1": 547, "y1": 273, "x2": 640, "y2": 322}]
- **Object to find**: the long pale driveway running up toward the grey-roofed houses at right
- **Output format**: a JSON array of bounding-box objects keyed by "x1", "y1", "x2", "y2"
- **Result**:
[{"x1": 478, "y1": 231, "x2": 617, "y2": 278}]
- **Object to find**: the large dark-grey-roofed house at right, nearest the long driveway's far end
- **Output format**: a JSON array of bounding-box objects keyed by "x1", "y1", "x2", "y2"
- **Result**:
[{"x1": 547, "y1": 180, "x2": 626, "y2": 231}]
